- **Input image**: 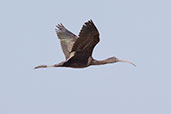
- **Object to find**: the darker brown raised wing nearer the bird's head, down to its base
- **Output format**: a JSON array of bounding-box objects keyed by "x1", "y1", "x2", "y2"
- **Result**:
[{"x1": 64, "y1": 20, "x2": 100, "y2": 64}]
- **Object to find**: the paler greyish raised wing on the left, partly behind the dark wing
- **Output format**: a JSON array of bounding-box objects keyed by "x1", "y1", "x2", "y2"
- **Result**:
[{"x1": 56, "y1": 24, "x2": 77, "y2": 59}]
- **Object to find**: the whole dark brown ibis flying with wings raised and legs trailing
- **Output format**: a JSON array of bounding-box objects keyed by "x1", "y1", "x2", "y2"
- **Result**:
[{"x1": 35, "y1": 20, "x2": 135, "y2": 69}]
